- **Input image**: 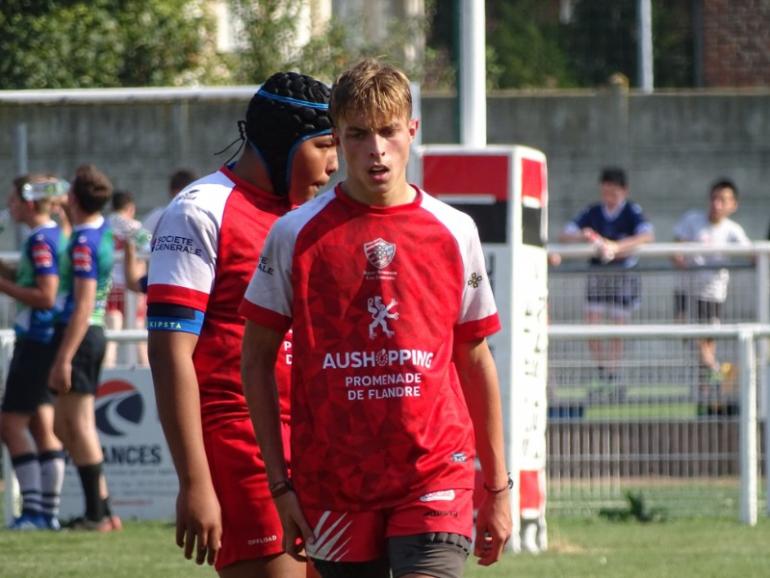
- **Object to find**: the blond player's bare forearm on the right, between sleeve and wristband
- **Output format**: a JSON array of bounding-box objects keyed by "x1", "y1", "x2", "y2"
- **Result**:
[{"x1": 455, "y1": 340, "x2": 508, "y2": 488}]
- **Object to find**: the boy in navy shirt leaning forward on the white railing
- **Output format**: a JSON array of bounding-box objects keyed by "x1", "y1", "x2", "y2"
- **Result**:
[{"x1": 559, "y1": 167, "x2": 654, "y2": 398}]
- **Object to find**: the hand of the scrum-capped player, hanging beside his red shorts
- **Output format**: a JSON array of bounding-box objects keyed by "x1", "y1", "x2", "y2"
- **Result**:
[{"x1": 176, "y1": 485, "x2": 222, "y2": 565}]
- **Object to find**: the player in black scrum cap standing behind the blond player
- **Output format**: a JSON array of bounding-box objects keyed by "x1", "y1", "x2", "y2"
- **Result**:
[{"x1": 148, "y1": 73, "x2": 337, "y2": 578}]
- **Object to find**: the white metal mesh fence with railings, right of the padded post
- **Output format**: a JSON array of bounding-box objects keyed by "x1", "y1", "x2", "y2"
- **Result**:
[{"x1": 547, "y1": 243, "x2": 770, "y2": 521}]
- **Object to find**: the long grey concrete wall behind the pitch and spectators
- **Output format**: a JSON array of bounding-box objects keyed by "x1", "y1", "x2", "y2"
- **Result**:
[{"x1": 0, "y1": 87, "x2": 770, "y2": 248}]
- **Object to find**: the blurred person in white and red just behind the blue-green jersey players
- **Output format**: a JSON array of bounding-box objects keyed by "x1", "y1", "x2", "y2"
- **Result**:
[{"x1": 104, "y1": 190, "x2": 147, "y2": 367}]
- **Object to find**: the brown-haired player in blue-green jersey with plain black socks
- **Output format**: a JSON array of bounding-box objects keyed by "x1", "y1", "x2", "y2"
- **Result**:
[{"x1": 48, "y1": 165, "x2": 122, "y2": 532}]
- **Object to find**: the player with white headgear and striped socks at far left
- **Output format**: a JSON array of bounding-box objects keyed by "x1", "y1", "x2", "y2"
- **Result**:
[{"x1": 0, "y1": 175, "x2": 68, "y2": 530}]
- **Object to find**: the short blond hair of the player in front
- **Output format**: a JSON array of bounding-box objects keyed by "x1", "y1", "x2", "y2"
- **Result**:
[{"x1": 329, "y1": 58, "x2": 412, "y2": 125}]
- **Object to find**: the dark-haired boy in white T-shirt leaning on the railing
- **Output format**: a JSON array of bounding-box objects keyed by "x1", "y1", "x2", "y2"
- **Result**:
[{"x1": 673, "y1": 179, "x2": 751, "y2": 412}]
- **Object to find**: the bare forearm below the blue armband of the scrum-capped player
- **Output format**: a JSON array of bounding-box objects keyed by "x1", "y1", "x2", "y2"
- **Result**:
[{"x1": 148, "y1": 332, "x2": 211, "y2": 487}]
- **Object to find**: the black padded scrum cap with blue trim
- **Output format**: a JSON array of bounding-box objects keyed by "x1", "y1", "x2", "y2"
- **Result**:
[{"x1": 246, "y1": 72, "x2": 332, "y2": 196}]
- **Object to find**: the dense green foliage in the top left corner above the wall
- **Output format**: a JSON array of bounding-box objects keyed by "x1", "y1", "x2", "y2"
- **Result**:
[{"x1": 0, "y1": 0, "x2": 211, "y2": 89}]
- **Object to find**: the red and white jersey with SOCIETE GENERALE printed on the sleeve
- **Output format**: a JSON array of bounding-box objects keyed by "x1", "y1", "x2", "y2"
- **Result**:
[{"x1": 147, "y1": 167, "x2": 291, "y2": 426}]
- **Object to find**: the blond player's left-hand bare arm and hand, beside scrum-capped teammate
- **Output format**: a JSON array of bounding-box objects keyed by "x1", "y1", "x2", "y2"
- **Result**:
[{"x1": 241, "y1": 320, "x2": 313, "y2": 559}]
